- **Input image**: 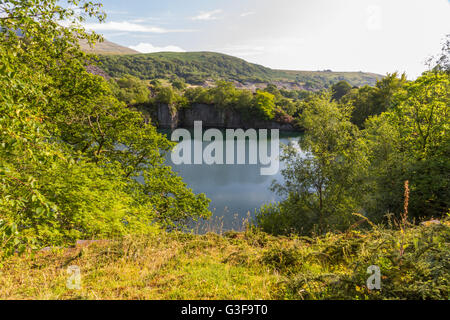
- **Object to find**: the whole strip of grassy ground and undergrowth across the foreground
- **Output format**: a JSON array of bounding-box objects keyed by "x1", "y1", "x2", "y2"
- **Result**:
[{"x1": 0, "y1": 222, "x2": 450, "y2": 300}]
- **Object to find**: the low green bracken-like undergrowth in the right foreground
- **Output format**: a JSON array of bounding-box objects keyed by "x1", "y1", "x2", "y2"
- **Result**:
[{"x1": 283, "y1": 222, "x2": 450, "y2": 300}]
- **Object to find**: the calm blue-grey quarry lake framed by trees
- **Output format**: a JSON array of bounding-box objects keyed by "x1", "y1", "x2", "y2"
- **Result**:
[{"x1": 160, "y1": 130, "x2": 302, "y2": 233}]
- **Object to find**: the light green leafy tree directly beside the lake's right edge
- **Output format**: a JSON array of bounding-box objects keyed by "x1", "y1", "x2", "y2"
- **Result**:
[{"x1": 257, "y1": 94, "x2": 367, "y2": 234}]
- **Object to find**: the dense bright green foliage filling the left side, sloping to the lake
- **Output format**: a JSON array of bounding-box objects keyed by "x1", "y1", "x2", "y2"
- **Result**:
[{"x1": 0, "y1": 0, "x2": 210, "y2": 255}]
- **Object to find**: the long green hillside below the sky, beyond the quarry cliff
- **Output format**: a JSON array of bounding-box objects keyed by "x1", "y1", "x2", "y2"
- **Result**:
[{"x1": 99, "y1": 52, "x2": 382, "y2": 90}]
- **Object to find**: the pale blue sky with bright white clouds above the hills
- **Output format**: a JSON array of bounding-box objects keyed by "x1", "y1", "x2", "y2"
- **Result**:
[{"x1": 81, "y1": 0, "x2": 450, "y2": 79}]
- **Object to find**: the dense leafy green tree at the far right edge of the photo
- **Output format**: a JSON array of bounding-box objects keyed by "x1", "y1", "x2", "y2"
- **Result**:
[{"x1": 366, "y1": 72, "x2": 450, "y2": 218}]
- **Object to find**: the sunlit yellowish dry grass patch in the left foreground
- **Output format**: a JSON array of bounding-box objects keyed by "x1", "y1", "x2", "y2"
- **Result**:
[{"x1": 0, "y1": 234, "x2": 279, "y2": 299}]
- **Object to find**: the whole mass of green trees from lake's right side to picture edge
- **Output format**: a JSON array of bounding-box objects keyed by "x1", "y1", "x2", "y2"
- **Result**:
[{"x1": 262, "y1": 71, "x2": 450, "y2": 234}]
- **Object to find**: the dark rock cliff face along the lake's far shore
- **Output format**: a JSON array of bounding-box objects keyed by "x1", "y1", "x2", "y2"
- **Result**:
[{"x1": 158, "y1": 104, "x2": 298, "y2": 131}]
